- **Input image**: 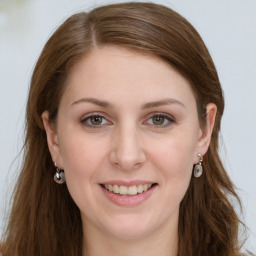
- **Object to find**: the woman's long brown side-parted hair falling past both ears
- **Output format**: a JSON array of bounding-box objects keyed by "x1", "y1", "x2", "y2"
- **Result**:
[{"x1": 0, "y1": 3, "x2": 248, "y2": 256}]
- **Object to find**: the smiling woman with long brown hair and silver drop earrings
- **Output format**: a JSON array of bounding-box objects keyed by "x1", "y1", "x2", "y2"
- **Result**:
[{"x1": 1, "y1": 3, "x2": 251, "y2": 256}]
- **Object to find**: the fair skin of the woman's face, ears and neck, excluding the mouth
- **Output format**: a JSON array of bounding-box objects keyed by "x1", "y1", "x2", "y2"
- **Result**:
[{"x1": 42, "y1": 46, "x2": 216, "y2": 256}]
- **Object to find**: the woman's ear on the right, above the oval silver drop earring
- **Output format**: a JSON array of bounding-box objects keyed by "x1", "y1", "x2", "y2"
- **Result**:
[{"x1": 195, "y1": 103, "x2": 217, "y2": 161}]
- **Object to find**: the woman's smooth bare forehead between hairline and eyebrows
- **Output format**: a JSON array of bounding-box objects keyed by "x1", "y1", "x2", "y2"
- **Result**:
[{"x1": 60, "y1": 46, "x2": 194, "y2": 107}]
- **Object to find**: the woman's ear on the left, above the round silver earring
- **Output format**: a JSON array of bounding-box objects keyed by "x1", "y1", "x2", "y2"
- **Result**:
[{"x1": 41, "y1": 111, "x2": 62, "y2": 168}]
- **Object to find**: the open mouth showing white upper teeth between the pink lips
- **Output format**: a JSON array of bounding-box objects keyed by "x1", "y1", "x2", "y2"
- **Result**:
[{"x1": 101, "y1": 183, "x2": 157, "y2": 196}]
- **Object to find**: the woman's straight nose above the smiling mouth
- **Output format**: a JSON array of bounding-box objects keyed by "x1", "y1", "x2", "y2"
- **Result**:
[{"x1": 110, "y1": 127, "x2": 146, "y2": 171}]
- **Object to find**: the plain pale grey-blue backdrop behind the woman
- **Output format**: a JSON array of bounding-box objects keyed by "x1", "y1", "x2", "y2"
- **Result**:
[{"x1": 0, "y1": 0, "x2": 256, "y2": 252}]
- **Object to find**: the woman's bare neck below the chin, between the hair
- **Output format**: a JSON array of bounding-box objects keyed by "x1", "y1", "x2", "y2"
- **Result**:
[{"x1": 83, "y1": 216, "x2": 178, "y2": 256}]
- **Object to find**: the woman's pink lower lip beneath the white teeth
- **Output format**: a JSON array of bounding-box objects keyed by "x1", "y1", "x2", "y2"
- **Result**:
[{"x1": 100, "y1": 185, "x2": 157, "y2": 206}]
